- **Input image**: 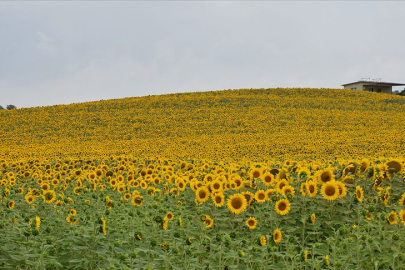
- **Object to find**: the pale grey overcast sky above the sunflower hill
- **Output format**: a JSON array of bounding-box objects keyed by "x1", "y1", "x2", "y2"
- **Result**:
[{"x1": 0, "y1": 1, "x2": 405, "y2": 107}]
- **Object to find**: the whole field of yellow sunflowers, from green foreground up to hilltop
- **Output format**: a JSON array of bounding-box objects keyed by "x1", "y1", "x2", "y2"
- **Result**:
[{"x1": 0, "y1": 88, "x2": 405, "y2": 269}]
